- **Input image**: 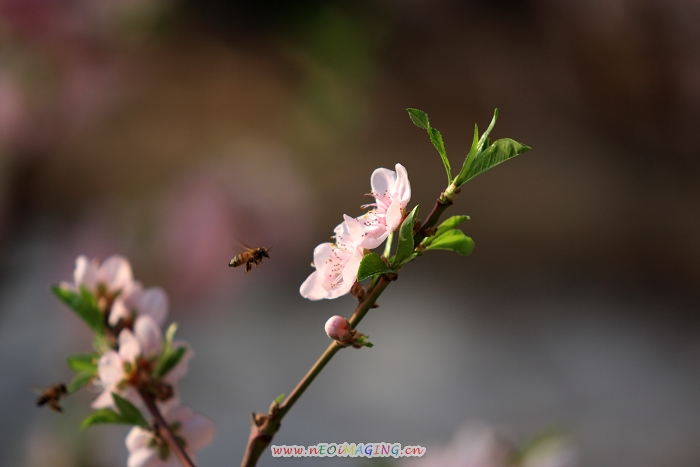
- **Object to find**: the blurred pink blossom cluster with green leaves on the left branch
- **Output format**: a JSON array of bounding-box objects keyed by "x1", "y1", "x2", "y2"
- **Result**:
[{"x1": 54, "y1": 255, "x2": 214, "y2": 467}]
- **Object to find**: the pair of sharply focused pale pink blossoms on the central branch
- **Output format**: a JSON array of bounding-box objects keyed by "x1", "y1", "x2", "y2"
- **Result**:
[{"x1": 299, "y1": 164, "x2": 411, "y2": 300}]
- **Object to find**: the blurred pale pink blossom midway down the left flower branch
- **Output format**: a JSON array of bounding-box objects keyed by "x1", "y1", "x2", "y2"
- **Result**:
[{"x1": 92, "y1": 315, "x2": 163, "y2": 409}]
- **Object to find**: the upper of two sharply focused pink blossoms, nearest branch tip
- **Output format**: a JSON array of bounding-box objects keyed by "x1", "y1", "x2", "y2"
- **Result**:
[{"x1": 359, "y1": 164, "x2": 411, "y2": 249}]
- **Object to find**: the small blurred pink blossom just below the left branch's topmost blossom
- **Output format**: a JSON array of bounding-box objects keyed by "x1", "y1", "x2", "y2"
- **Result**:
[{"x1": 109, "y1": 281, "x2": 168, "y2": 326}]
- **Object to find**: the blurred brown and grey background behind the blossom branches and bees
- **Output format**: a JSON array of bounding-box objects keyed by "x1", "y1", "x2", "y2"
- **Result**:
[{"x1": 0, "y1": 0, "x2": 700, "y2": 467}]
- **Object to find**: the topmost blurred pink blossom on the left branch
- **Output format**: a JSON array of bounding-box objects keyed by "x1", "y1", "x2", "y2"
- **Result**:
[{"x1": 61, "y1": 255, "x2": 134, "y2": 297}]
